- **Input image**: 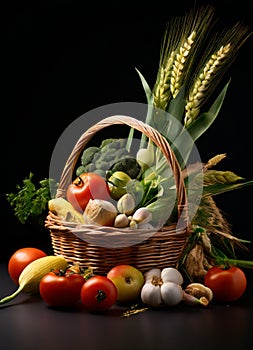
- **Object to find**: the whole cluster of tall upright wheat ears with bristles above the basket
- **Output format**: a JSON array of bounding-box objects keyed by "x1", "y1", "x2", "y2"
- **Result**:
[{"x1": 152, "y1": 5, "x2": 252, "y2": 127}]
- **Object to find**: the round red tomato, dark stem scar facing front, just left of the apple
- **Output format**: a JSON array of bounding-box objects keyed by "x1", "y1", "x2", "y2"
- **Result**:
[{"x1": 81, "y1": 276, "x2": 118, "y2": 312}]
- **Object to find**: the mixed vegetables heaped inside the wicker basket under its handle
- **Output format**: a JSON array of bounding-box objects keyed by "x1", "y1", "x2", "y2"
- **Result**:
[{"x1": 61, "y1": 138, "x2": 172, "y2": 228}]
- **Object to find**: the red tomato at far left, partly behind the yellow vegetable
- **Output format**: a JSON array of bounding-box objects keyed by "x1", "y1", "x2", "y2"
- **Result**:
[{"x1": 8, "y1": 247, "x2": 47, "y2": 284}]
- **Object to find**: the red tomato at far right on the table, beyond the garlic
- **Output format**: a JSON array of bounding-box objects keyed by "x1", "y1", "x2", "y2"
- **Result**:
[{"x1": 204, "y1": 266, "x2": 247, "y2": 302}]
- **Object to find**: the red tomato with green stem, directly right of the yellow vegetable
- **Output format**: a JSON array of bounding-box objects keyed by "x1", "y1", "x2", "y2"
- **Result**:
[{"x1": 39, "y1": 270, "x2": 85, "y2": 307}]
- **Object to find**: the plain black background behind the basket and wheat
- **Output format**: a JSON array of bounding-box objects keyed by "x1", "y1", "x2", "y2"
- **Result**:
[{"x1": 0, "y1": 0, "x2": 253, "y2": 260}]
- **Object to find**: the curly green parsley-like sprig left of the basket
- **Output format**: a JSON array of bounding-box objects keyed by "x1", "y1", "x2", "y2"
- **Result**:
[{"x1": 6, "y1": 173, "x2": 58, "y2": 224}]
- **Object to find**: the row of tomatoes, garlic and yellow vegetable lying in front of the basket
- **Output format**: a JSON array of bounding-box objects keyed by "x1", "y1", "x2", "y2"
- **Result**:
[{"x1": 0, "y1": 247, "x2": 247, "y2": 317}]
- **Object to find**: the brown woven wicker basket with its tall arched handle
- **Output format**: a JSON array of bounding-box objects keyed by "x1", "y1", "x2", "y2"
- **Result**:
[{"x1": 45, "y1": 116, "x2": 190, "y2": 274}]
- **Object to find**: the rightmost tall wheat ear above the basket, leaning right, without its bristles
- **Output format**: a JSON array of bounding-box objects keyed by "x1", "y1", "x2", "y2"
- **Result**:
[{"x1": 184, "y1": 43, "x2": 231, "y2": 126}]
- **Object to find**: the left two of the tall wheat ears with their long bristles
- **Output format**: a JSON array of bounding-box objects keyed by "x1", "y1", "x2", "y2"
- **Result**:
[{"x1": 153, "y1": 6, "x2": 214, "y2": 110}]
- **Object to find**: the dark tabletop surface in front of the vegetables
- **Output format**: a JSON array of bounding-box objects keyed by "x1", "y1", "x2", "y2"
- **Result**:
[{"x1": 0, "y1": 263, "x2": 253, "y2": 350}]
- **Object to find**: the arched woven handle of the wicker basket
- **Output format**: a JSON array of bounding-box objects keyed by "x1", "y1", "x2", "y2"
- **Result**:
[{"x1": 56, "y1": 115, "x2": 188, "y2": 226}]
